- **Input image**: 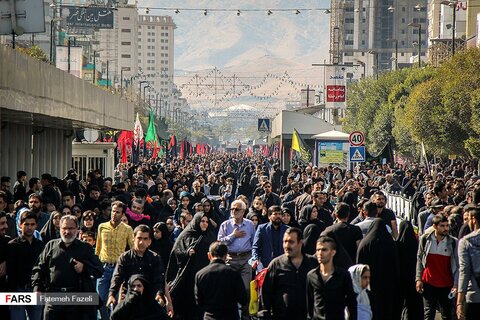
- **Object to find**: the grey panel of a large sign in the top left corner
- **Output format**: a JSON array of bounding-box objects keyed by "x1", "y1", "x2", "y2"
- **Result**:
[{"x1": 0, "y1": 0, "x2": 45, "y2": 35}]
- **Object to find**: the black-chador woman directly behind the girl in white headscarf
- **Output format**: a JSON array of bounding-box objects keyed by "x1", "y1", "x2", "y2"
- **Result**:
[{"x1": 357, "y1": 218, "x2": 401, "y2": 320}]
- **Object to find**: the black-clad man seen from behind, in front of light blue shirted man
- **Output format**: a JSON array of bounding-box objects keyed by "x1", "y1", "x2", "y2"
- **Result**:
[{"x1": 195, "y1": 241, "x2": 248, "y2": 320}]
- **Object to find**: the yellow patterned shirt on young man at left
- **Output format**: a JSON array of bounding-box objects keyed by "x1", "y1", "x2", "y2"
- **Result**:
[{"x1": 95, "y1": 221, "x2": 133, "y2": 264}]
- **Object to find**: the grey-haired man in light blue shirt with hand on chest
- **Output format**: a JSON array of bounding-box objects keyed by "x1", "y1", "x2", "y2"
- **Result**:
[{"x1": 218, "y1": 200, "x2": 255, "y2": 319}]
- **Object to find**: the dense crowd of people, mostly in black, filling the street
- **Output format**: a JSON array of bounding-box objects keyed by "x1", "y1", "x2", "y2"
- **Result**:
[{"x1": 0, "y1": 152, "x2": 480, "y2": 320}]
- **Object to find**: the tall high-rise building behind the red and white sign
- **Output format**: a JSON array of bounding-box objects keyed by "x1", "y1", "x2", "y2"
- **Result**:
[{"x1": 330, "y1": 0, "x2": 428, "y2": 78}]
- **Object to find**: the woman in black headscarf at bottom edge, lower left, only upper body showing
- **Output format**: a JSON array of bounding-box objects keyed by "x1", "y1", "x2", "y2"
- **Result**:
[{"x1": 110, "y1": 274, "x2": 168, "y2": 320}]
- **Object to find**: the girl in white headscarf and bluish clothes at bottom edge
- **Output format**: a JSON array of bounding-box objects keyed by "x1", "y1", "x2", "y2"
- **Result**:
[{"x1": 348, "y1": 264, "x2": 373, "y2": 320}]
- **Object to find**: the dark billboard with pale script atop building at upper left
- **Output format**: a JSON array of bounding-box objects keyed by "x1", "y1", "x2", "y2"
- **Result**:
[{"x1": 62, "y1": 6, "x2": 114, "y2": 29}]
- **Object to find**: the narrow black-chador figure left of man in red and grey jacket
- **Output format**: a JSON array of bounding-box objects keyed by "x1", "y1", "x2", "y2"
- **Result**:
[{"x1": 397, "y1": 221, "x2": 423, "y2": 320}]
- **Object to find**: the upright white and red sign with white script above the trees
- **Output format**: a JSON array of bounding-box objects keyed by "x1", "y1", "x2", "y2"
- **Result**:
[{"x1": 325, "y1": 65, "x2": 347, "y2": 109}]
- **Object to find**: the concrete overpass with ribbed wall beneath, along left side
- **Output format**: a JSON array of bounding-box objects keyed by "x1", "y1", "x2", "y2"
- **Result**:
[{"x1": 0, "y1": 46, "x2": 134, "y2": 179}]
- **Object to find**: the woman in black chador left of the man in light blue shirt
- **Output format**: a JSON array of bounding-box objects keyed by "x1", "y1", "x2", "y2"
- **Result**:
[{"x1": 165, "y1": 213, "x2": 215, "y2": 319}]
